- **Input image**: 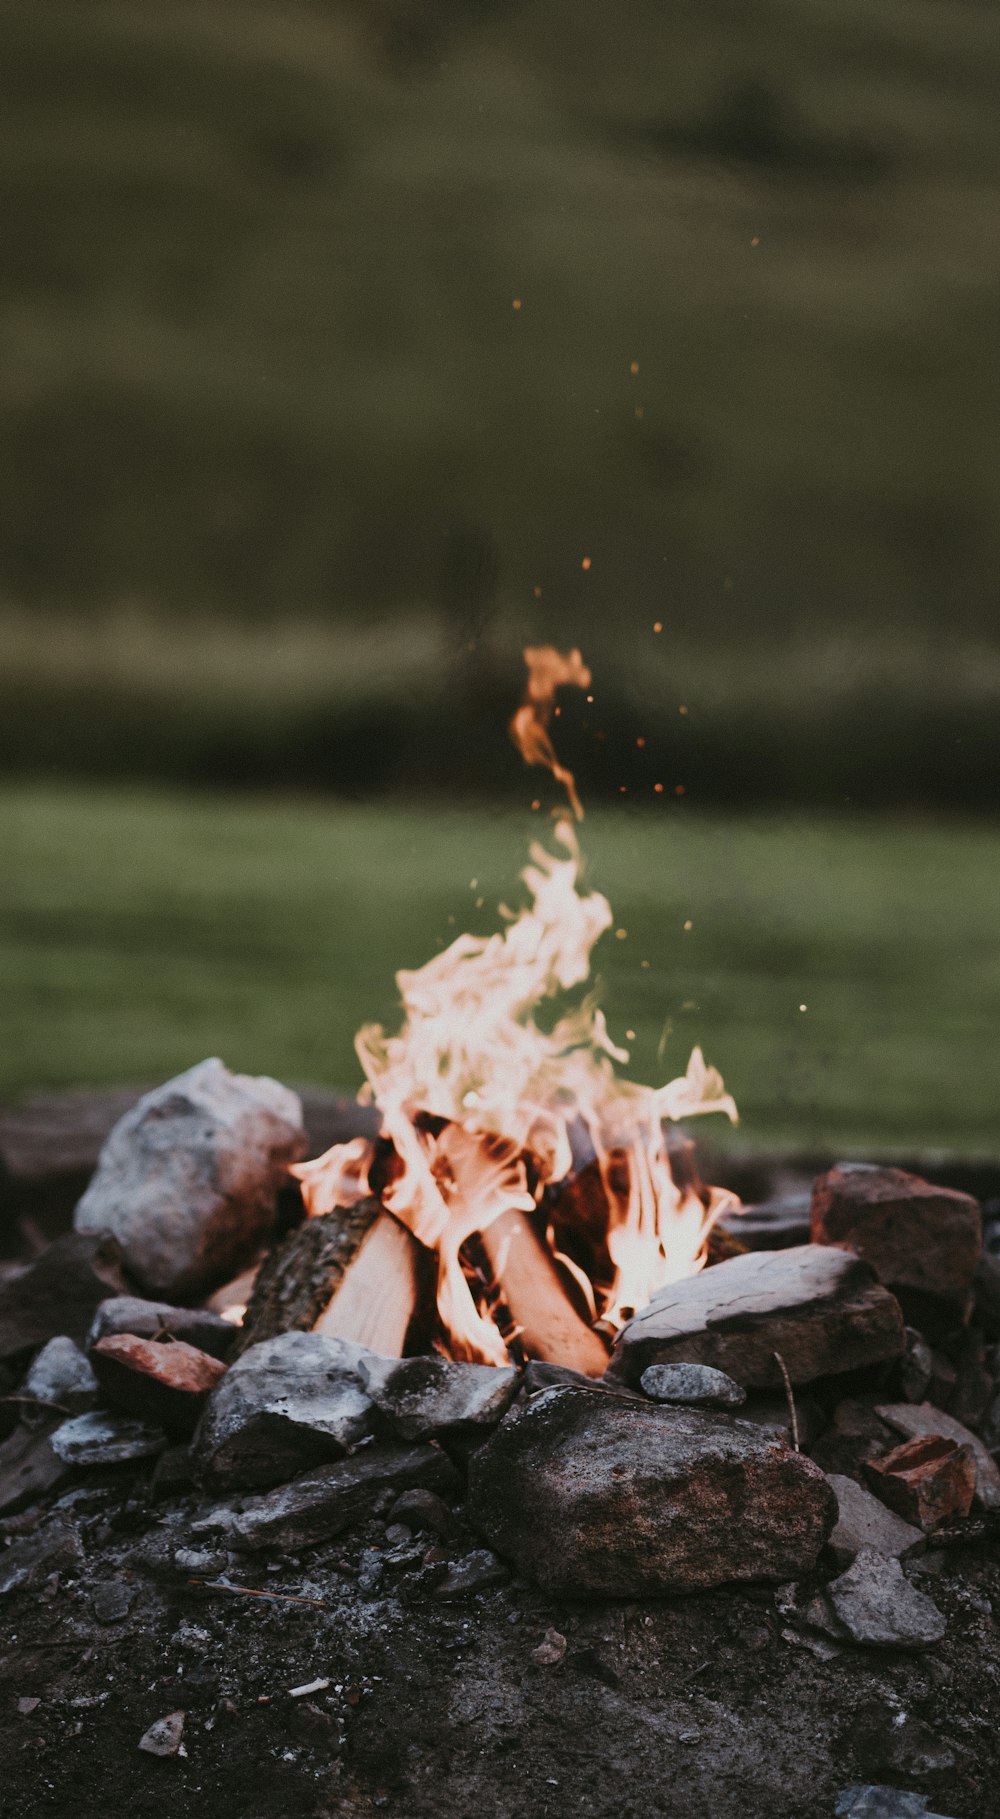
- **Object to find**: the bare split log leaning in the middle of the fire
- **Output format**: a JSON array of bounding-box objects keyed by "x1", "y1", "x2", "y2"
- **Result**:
[{"x1": 480, "y1": 1211, "x2": 607, "y2": 1377}]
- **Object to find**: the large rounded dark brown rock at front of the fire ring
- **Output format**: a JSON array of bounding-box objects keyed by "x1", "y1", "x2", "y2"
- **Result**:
[{"x1": 465, "y1": 1390, "x2": 836, "y2": 1597}]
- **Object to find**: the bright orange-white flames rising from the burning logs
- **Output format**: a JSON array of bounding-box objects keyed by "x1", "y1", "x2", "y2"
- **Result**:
[{"x1": 293, "y1": 648, "x2": 738, "y2": 1364}]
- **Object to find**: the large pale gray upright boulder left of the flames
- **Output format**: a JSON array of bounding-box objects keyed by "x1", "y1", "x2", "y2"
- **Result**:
[{"x1": 75, "y1": 1059, "x2": 305, "y2": 1297}]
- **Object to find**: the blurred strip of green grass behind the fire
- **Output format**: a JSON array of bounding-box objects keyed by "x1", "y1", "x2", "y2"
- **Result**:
[{"x1": 0, "y1": 786, "x2": 1000, "y2": 1153}]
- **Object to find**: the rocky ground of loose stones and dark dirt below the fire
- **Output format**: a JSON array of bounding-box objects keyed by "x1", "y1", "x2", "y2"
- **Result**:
[{"x1": 0, "y1": 1084, "x2": 1000, "y2": 1819}]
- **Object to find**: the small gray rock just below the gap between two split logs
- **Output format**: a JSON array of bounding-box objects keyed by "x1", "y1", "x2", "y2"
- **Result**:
[{"x1": 360, "y1": 1352, "x2": 518, "y2": 1441}]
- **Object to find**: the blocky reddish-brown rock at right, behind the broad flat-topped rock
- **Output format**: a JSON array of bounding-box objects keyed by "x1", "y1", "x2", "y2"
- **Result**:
[{"x1": 811, "y1": 1162, "x2": 982, "y2": 1326}]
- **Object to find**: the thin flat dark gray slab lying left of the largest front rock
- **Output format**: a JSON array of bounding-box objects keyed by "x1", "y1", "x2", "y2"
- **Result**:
[{"x1": 229, "y1": 1444, "x2": 456, "y2": 1552}]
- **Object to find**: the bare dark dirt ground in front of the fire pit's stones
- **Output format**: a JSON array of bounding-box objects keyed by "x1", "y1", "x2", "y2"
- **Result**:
[{"x1": 0, "y1": 1468, "x2": 1000, "y2": 1819}]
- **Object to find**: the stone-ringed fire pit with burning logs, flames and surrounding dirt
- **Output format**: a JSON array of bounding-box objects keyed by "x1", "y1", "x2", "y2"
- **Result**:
[{"x1": 0, "y1": 649, "x2": 1000, "y2": 1819}]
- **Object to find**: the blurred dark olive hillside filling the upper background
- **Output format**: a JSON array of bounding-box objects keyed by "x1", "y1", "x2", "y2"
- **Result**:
[{"x1": 0, "y1": 0, "x2": 1000, "y2": 808}]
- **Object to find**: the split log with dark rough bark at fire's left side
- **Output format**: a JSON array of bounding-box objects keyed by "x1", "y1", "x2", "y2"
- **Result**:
[{"x1": 236, "y1": 1197, "x2": 424, "y2": 1357}]
